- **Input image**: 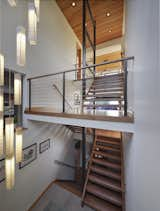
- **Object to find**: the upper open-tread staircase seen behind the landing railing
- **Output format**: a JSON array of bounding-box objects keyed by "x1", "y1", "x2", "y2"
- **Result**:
[{"x1": 83, "y1": 73, "x2": 124, "y2": 110}]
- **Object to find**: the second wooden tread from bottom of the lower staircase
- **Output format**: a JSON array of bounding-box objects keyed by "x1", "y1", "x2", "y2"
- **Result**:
[{"x1": 87, "y1": 183, "x2": 122, "y2": 206}]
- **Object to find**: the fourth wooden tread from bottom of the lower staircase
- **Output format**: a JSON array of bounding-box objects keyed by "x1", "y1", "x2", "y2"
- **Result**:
[{"x1": 91, "y1": 165, "x2": 121, "y2": 181}]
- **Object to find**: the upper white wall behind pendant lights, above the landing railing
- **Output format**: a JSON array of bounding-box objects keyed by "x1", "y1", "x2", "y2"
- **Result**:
[{"x1": 1, "y1": 0, "x2": 77, "y2": 76}]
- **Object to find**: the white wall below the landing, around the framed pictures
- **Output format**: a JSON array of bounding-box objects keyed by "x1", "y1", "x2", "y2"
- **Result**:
[{"x1": 0, "y1": 122, "x2": 74, "y2": 211}]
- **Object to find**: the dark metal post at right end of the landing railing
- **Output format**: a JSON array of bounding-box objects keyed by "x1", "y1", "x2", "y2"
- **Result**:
[{"x1": 123, "y1": 60, "x2": 128, "y2": 116}]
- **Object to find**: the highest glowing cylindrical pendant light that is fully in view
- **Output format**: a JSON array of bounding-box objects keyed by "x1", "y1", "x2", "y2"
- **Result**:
[{"x1": 28, "y1": 2, "x2": 37, "y2": 45}]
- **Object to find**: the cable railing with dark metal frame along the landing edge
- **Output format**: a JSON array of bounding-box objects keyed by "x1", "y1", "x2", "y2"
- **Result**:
[{"x1": 27, "y1": 57, "x2": 134, "y2": 116}]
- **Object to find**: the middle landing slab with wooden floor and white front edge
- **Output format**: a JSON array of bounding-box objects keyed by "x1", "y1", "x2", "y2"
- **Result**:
[{"x1": 25, "y1": 108, "x2": 134, "y2": 133}]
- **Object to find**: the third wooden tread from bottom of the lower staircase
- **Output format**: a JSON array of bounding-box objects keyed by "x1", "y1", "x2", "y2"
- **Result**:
[{"x1": 89, "y1": 174, "x2": 122, "y2": 192}]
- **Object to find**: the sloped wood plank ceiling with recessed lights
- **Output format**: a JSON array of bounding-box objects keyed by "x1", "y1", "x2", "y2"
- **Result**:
[{"x1": 56, "y1": 0, "x2": 123, "y2": 44}]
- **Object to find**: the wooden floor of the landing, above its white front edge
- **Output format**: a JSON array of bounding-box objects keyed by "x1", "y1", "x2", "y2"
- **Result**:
[{"x1": 25, "y1": 107, "x2": 134, "y2": 123}]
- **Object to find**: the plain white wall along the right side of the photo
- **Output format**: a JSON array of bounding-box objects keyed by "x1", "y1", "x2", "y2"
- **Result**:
[{"x1": 125, "y1": 0, "x2": 160, "y2": 211}]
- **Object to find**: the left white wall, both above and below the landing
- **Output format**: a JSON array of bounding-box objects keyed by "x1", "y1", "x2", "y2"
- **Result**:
[{"x1": 0, "y1": 0, "x2": 77, "y2": 211}]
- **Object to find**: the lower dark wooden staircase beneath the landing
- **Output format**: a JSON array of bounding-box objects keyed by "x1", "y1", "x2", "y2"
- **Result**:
[{"x1": 82, "y1": 135, "x2": 125, "y2": 211}]
